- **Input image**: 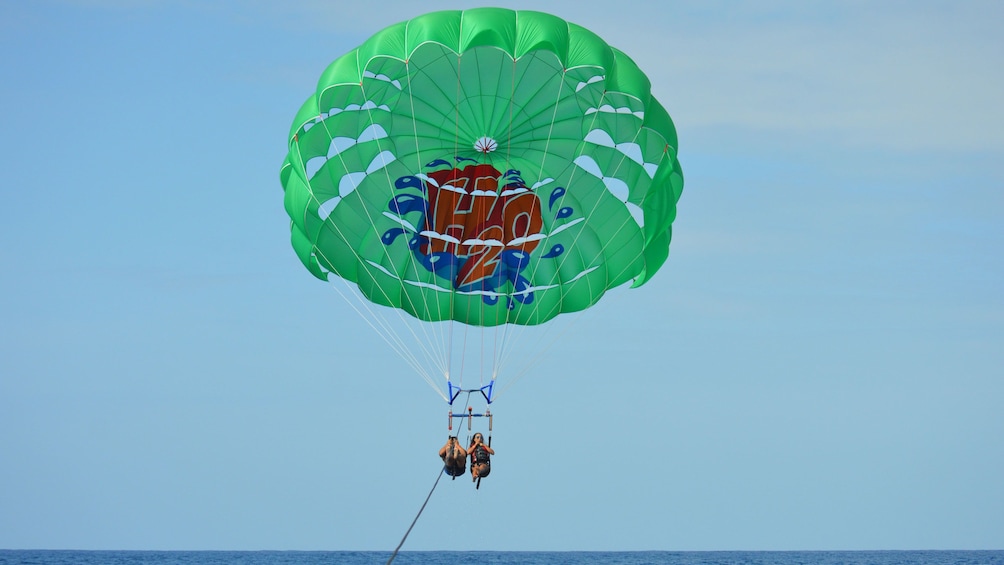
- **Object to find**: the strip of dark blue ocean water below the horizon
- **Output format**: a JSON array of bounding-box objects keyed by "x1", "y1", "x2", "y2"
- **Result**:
[{"x1": 0, "y1": 550, "x2": 1004, "y2": 565}]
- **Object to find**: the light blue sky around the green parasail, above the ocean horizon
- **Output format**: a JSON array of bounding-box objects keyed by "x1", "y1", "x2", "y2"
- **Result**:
[{"x1": 0, "y1": 0, "x2": 1004, "y2": 550}]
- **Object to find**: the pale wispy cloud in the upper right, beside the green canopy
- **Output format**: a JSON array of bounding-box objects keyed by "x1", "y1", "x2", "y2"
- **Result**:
[{"x1": 636, "y1": 3, "x2": 1004, "y2": 152}]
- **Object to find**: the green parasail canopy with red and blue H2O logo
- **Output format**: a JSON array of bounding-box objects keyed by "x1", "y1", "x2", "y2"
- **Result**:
[{"x1": 280, "y1": 8, "x2": 683, "y2": 326}]
